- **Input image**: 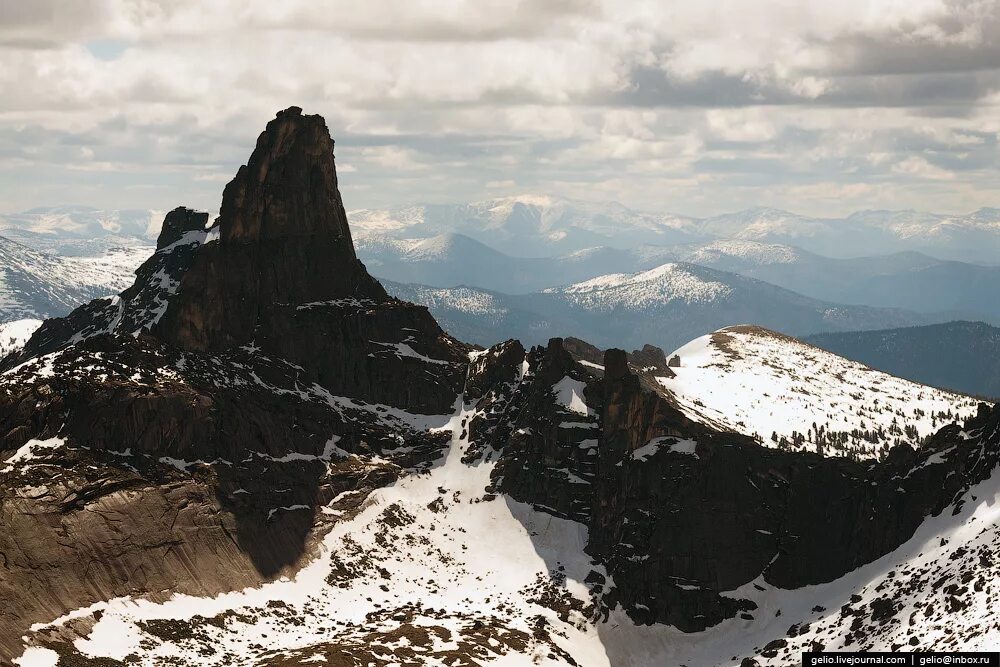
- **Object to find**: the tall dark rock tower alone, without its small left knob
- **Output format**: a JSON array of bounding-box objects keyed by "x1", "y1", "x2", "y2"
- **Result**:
[{"x1": 156, "y1": 107, "x2": 388, "y2": 351}]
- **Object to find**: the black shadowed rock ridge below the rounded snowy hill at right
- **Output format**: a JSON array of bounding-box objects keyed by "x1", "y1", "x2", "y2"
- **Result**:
[{"x1": 495, "y1": 339, "x2": 1000, "y2": 631}]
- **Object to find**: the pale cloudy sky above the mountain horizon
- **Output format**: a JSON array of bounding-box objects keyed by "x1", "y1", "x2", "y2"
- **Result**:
[{"x1": 0, "y1": 0, "x2": 1000, "y2": 215}]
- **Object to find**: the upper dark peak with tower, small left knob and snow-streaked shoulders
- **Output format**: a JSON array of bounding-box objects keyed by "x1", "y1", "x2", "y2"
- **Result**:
[{"x1": 4, "y1": 107, "x2": 467, "y2": 410}]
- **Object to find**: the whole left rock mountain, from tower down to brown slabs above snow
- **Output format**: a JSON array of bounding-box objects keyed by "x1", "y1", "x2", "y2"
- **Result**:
[{"x1": 0, "y1": 108, "x2": 471, "y2": 656}]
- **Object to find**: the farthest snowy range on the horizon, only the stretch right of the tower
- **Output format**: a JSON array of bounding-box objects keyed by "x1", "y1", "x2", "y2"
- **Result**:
[{"x1": 349, "y1": 196, "x2": 1000, "y2": 263}]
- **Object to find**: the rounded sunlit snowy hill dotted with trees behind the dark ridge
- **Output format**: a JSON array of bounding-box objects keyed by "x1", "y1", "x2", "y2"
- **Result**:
[{"x1": 658, "y1": 326, "x2": 979, "y2": 458}]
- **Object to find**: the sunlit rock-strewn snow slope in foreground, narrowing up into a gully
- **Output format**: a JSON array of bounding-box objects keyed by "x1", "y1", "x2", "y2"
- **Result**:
[{"x1": 21, "y1": 404, "x2": 627, "y2": 667}]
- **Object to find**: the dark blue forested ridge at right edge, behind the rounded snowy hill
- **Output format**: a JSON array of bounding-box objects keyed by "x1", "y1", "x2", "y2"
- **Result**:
[{"x1": 806, "y1": 322, "x2": 1000, "y2": 398}]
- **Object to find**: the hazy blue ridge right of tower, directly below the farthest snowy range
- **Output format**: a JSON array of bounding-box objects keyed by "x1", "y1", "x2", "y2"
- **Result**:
[{"x1": 355, "y1": 233, "x2": 1000, "y2": 323}]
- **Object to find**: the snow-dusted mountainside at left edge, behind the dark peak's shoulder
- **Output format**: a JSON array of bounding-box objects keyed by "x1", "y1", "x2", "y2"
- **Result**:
[{"x1": 0, "y1": 237, "x2": 153, "y2": 322}]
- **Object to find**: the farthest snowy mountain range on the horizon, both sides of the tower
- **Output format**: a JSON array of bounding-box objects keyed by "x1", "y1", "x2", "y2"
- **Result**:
[{"x1": 7, "y1": 195, "x2": 1000, "y2": 270}]
